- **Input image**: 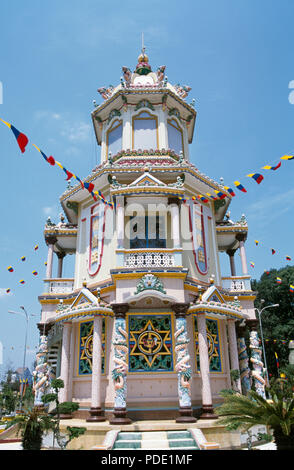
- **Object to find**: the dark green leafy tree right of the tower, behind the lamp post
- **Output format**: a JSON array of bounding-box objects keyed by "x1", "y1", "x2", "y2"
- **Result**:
[{"x1": 252, "y1": 266, "x2": 294, "y2": 376}]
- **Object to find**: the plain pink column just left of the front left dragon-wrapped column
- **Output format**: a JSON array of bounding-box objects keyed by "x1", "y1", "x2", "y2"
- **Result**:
[{"x1": 87, "y1": 315, "x2": 106, "y2": 422}]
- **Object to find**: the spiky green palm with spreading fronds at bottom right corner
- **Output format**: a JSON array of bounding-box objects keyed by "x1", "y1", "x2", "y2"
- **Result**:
[{"x1": 216, "y1": 379, "x2": 294, "y2": 450}]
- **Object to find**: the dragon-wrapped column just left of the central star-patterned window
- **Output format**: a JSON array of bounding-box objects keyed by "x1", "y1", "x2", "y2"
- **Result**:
[{"x1": 109, "y1": 303, "x2": 132, "y2": 424}]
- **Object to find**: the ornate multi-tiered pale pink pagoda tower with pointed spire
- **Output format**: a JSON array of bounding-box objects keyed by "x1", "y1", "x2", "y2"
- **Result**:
[{"x1": 35, "y1": 48, "x2": 264, "y2": 424}]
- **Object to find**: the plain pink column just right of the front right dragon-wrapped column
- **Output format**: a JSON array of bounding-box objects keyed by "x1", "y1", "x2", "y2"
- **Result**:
[{"x1": 197, "y1": 312, "x2": 218, "y2": 419}]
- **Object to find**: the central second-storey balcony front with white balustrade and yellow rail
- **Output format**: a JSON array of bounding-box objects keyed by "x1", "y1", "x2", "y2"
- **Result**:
[{"x1": 117, "y1": 248, "x2": 182, "y2": 269}]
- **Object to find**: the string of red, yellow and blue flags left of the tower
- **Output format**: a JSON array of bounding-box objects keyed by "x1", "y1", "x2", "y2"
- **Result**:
[{"x1": 0, "y1": 118, "x2": 114, "y2": 209}]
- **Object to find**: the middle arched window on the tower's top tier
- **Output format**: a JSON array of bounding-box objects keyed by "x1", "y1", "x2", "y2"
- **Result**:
[{"x1": 133, "y1": 111, "x2": 158, "y2": 150}]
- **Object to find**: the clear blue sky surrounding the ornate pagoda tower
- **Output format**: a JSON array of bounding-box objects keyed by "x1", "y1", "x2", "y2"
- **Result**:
[{"x1": 0, "y1": 0, "x2": 294, "y2": 372}]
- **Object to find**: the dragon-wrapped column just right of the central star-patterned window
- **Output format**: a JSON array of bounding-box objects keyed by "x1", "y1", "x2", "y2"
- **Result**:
[{"x1": 171, "y1": 303, "x2": 196, "y2": 423}]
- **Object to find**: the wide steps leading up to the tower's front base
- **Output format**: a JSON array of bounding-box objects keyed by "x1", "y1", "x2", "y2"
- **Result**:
[{"x1": 112, "y1": 430, "x2": 199, "y2": 450}]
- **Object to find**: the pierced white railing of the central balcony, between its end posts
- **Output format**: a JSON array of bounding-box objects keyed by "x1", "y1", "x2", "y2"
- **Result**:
[{"x1": 124, "y1": 250, "x2": 175, "y2": 268}]
